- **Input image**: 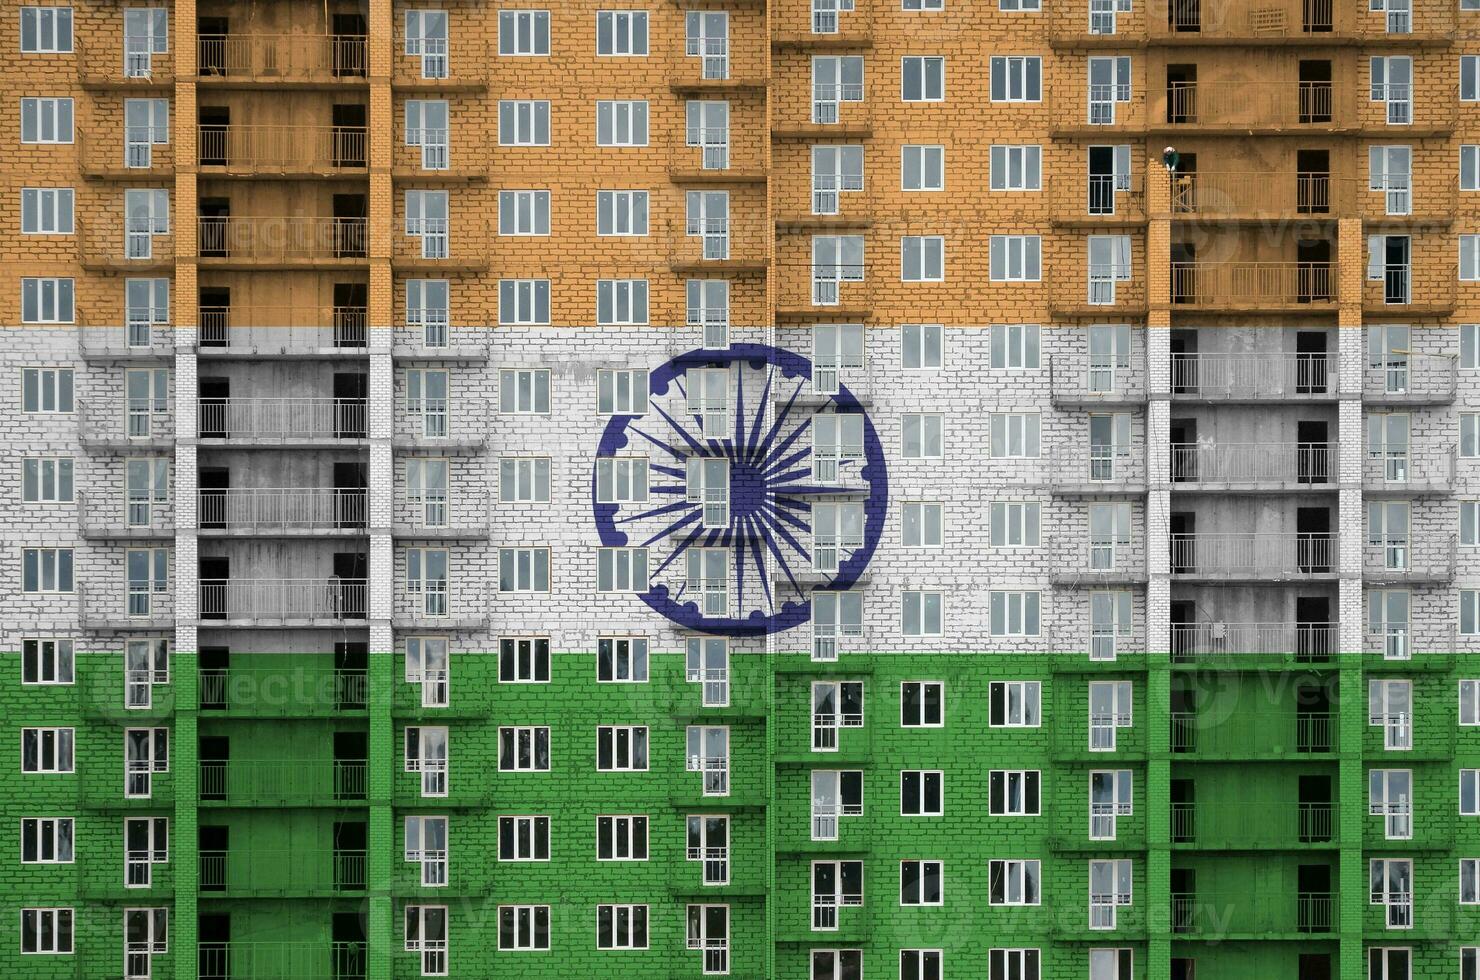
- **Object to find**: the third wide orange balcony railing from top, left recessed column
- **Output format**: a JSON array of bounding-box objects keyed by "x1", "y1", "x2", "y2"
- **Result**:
[{"x1": 198, "y1": 216, "x2": 369, "y2": 269}]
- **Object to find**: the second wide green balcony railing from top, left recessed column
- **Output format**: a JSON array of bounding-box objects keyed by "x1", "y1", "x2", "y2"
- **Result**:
[{"x1": 200, "y1": 758, "x2": 369, "y2": 807}]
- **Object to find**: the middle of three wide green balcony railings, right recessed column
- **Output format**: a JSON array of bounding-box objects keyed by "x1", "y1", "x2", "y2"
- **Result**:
[{"x1": 1171, "y1": 802, "x2": 1336, "y2": 850}]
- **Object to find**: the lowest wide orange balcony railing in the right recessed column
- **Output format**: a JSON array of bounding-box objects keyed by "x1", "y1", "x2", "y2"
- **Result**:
[{"x1": 1171, "y1": 262, "x2": 1336, "y2": 312}]
